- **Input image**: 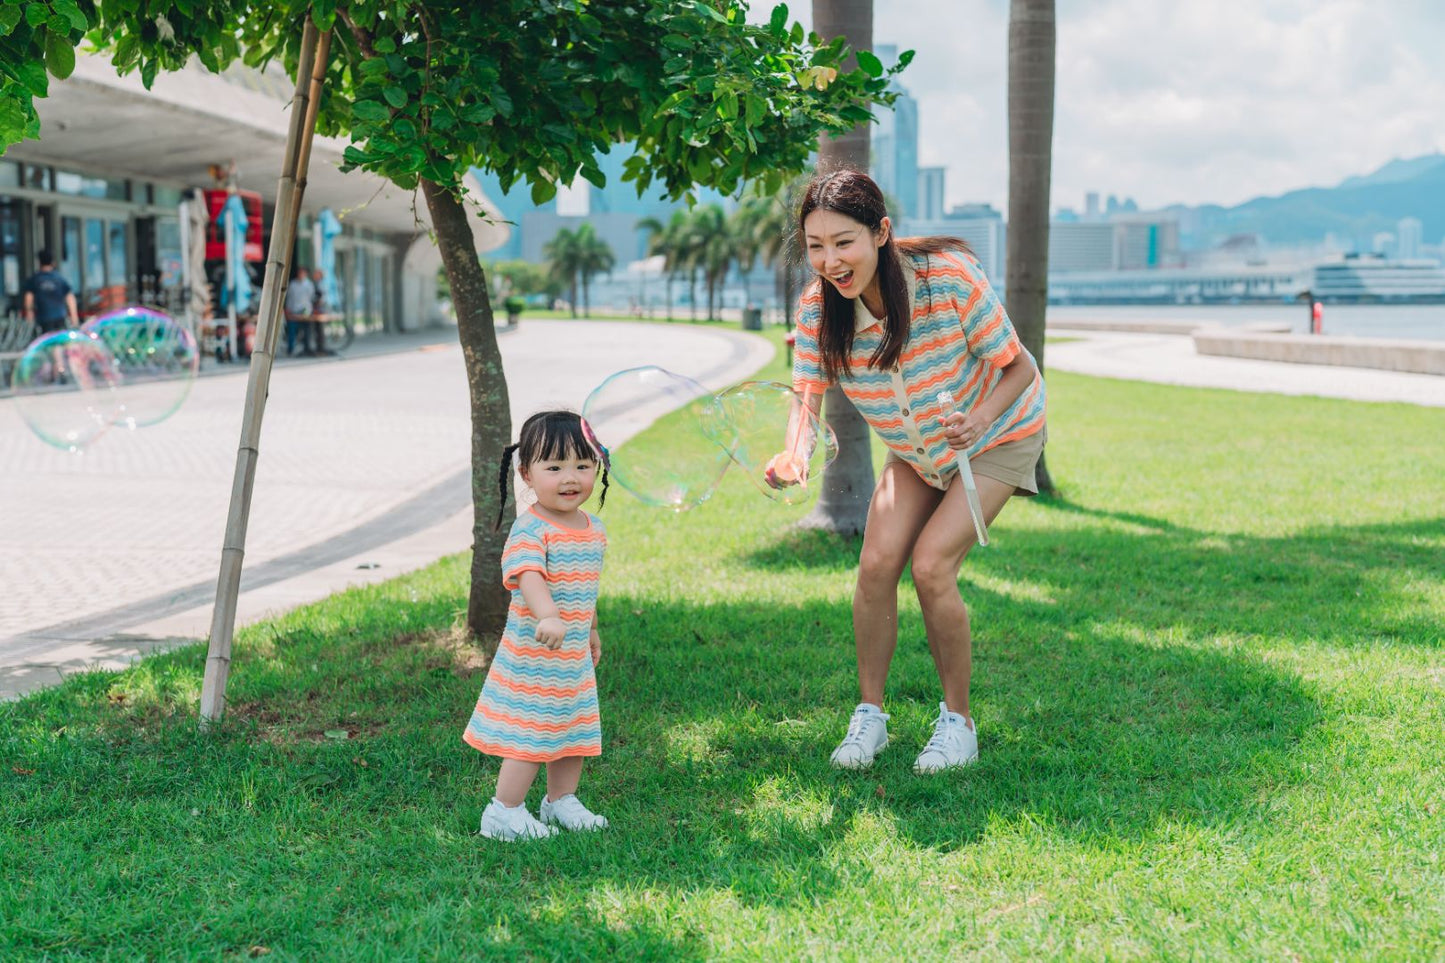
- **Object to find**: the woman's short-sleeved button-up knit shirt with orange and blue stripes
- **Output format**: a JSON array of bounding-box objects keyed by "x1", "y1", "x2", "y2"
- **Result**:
[{"x1": 793, "y1": 252, "x2": 1045, "y2": 489}]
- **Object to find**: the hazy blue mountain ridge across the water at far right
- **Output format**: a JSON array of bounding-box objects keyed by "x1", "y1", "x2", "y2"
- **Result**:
[{"x1": 1165, "y1": 153, "x2": 1445, "y2": 250}]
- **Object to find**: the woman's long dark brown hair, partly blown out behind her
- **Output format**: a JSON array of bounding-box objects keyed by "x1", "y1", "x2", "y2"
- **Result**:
[{"x1": 798, "y1": 168, "x2": 971, "y2": 382}]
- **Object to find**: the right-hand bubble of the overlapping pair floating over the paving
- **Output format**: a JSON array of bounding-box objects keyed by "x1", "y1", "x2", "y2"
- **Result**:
[{"x1": 82, "y1": 307, "x2": 201, "y2": 428}]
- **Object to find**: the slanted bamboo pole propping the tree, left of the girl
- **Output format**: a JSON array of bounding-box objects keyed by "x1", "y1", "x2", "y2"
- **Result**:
[{"x1": 201, "y1": 17, "x2": 331, "y2": 727}]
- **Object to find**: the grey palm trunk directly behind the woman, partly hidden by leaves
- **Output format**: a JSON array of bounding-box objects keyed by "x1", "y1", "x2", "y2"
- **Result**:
[{"x1": 799, "y1": 0, "x2": 874, "y2": 535}]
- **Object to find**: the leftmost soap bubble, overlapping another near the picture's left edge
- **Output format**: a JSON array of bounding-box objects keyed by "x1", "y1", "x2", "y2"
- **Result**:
[{"x1": 10, "y1": 331, "x2": 121, "y2": 451}]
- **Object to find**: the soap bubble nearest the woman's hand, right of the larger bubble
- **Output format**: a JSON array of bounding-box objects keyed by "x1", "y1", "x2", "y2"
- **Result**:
[{"x1": 718, "y1": 382, "x2": 838, "y2": 505}]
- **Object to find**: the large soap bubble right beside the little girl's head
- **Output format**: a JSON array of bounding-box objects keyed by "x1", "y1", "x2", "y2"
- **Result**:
[{"x1": 582, "y1": 364, "x2": 733, "y2": 512}]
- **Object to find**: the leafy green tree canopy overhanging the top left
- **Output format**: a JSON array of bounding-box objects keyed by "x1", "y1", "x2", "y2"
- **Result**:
[{"x1": 0, "y1": 0, "x2": 912, "y2": 202}]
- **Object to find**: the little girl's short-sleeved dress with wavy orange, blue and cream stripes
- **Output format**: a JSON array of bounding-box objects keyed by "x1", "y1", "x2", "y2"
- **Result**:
[{"x1": 462, "y1": 508, "x2": 607, "y2": 762}]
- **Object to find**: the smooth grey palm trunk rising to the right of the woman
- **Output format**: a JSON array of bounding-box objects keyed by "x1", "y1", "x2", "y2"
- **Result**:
[{"x1": 1006, "y1": 0, "x2": 1055, "y2": 495}]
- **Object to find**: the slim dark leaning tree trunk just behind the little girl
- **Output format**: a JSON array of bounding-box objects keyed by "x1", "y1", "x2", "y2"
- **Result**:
[{"x1": 422, "y1": 179, "x2": 513, "y2": 655}]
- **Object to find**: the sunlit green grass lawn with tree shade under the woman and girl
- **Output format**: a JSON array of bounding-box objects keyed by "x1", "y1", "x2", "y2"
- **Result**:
[{"x1": 0, "y1": 333, "x2": 1445, "y2": 960}]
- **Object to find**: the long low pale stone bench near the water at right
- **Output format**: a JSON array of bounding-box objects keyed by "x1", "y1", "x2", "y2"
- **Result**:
[{"x1": 1194, "y1": 327, "x2": 1445, "y2": 376}]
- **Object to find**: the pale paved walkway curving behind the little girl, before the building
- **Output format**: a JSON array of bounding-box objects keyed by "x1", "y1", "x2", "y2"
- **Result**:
[{"x1": 0, "y1": 321, "x2": 773, "y2": 698}]
